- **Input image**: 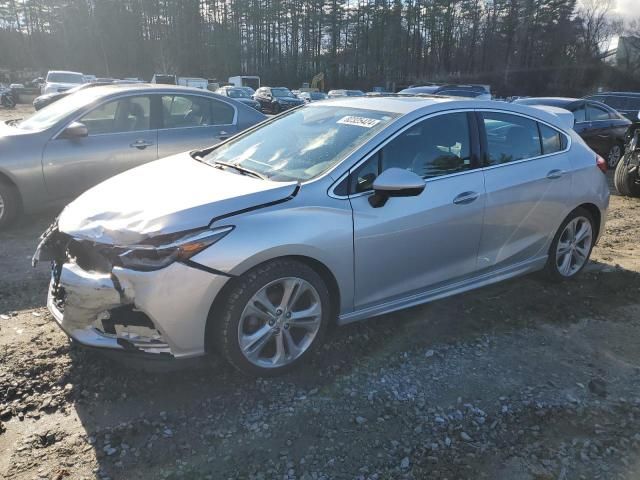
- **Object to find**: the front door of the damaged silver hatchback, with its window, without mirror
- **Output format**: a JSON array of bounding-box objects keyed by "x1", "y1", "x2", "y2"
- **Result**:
[{"x1": 349, "y1": 112, "x2": 485, "y2": 308}]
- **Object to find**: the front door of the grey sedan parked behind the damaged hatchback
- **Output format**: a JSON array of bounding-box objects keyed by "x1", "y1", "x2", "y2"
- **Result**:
[{"x1": 42, "y1": 95, "x2": 158, "y2": 199}]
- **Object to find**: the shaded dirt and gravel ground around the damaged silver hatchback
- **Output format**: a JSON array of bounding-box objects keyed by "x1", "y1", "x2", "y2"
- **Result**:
[{"x1": 0, "y1": 106, "x2": 640, "y2": 480}]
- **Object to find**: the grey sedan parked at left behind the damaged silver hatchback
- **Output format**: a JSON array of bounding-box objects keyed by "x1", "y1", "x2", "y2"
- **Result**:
[{"x1": 0, "y1": 84, "x2": 265, "y2": 228}]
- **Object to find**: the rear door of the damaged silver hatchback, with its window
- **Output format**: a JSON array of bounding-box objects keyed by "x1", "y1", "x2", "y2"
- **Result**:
[{"x1": 478, "y1": 111, "x2": 571, "y2": 271}]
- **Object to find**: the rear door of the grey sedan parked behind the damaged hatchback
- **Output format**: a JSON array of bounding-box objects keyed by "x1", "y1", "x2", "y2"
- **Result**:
[{"x1": 158, "y1": 94, "x2": 237, "y2": 158}]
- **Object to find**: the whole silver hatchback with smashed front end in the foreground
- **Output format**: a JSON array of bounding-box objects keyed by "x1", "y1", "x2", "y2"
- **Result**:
[{"x1": 34, "y1": 97, "x2": 609, "y2": 375}]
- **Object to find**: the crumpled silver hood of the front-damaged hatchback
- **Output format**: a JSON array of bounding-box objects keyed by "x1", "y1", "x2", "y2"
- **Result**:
[{"x1": 58, "y1": 153, "x2": 297, "y2": 246}]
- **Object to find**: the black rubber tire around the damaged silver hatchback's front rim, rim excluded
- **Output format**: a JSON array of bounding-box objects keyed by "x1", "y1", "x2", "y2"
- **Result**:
[{"x1": 210, "y1": 259, "x2": 331, "y2": 377}]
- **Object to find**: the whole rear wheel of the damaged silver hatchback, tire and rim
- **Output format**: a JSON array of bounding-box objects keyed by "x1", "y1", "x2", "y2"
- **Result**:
[{"x1": 545, "y1": 208, "x2": 595, "y2": 282}]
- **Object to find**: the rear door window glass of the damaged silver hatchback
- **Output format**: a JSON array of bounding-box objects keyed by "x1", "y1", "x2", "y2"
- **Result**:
[{"x1": 482, "y1": 112, "x2": 542, "y2": 166}]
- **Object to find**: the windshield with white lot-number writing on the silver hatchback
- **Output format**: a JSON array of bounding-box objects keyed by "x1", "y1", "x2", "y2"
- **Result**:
[{"x1": 205, "y1": 106, "x2": 397, "y2": 182}]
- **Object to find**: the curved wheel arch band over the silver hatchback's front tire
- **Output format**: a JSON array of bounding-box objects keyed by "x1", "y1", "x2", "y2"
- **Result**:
[{"x1": 205, "y1": 255, "x2": 341, "y2": 353}]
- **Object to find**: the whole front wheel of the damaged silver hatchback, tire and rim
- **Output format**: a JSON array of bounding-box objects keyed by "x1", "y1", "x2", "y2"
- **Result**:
[{"x1": 213, "y1": 259, "x2": 331, "y2": 377}]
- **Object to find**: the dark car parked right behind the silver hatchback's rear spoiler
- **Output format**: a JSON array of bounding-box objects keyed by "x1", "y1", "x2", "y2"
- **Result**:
[{"x1": 513, "y1": 97, "x2": 631, "y2": 168}]
